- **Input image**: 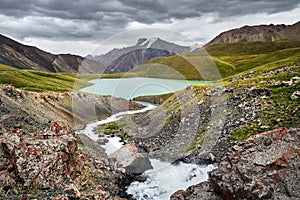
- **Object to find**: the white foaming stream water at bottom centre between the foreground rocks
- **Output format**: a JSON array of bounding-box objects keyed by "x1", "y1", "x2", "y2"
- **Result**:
[{"x1": 127, "y1": 160, "x2": 215, "y2": 200}]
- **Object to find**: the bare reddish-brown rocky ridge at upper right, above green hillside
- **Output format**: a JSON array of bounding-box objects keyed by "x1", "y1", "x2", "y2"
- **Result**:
[{"x1": 204, "y1": 21, "x2": 300, "y2": 47}]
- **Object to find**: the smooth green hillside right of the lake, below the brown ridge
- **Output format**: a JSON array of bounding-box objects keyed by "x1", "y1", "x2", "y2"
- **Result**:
[{"x1": 132, "y1": 41, "x2": 300, "y2": 80}]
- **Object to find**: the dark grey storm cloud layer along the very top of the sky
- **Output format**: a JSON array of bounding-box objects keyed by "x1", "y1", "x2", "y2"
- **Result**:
[{"x1": 0, "y1": 0, "x2": 299, "y2": 23}]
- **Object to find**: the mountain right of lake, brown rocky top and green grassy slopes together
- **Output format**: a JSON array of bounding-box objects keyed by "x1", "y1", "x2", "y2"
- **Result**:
[{"x1": 131, "y1": 22, "x2": 300, "y2": 80}]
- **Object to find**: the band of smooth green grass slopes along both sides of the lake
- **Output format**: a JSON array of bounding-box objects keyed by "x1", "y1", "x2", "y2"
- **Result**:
[{"x1": 0, "y1": 41, "x2": 300, "y2": 92}]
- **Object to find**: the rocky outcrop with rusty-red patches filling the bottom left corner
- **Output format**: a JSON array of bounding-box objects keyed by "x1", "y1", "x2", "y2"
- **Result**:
[{"x1": 0, "y1": 123, "x2": 126, "y2": 199}]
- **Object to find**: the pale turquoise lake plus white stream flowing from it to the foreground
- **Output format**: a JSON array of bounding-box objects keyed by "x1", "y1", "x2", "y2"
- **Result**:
[{"x1": 77, "y1": 78, "x2": 215, "y2": 200}]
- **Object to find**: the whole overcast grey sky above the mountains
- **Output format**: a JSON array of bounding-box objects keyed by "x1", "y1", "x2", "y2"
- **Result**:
[{"x1": 0, "y1": 0, "x2": 300, "y2": 56}]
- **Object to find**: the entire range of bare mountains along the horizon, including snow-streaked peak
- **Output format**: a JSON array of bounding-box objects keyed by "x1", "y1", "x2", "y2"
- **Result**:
[{"x1": 0, "y1": 22, "x2": 300, "y2": 74}]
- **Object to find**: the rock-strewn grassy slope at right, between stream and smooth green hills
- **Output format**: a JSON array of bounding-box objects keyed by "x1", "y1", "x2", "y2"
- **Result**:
[{"x1": 152, "y1": 66, "x2": 300, "y2": 151}]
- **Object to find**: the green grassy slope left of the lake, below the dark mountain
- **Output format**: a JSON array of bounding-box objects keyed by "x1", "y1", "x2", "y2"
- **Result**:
[{"x1": 0, "y1": 64, "x2": 90, "y2": 92}]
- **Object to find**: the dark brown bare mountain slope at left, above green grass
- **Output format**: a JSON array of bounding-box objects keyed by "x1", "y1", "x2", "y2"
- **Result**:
[{"x1": 0, "y1": 35, "x2": 104, "y2": 73}]
